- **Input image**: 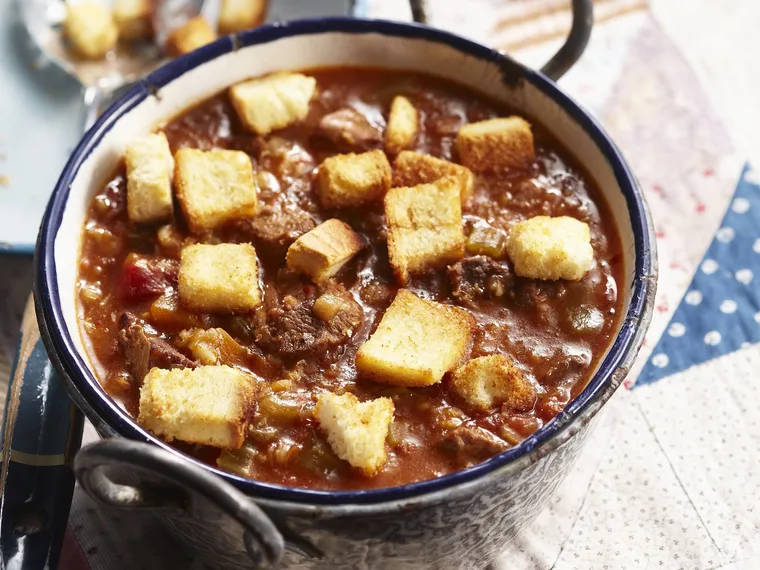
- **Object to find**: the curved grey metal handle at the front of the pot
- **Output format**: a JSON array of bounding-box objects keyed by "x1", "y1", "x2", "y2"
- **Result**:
[{"x1": 74, "y1": 439, "x2": 285, "y2": 568}]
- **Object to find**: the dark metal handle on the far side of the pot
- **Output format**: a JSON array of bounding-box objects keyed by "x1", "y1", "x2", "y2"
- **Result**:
[{"x1": 409, "y1": 0, "x2": 594, "y2": 81}]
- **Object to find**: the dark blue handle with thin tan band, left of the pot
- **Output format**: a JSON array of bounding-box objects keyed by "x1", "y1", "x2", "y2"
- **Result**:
[{"x1": 0, "y1": 339, "x2": 83, "y2": 570}]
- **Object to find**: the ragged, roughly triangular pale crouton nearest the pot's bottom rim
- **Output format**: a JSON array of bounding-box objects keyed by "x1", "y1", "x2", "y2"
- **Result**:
[{"x1": 314, "y1": 392, "x2": 394, "y2": 475}]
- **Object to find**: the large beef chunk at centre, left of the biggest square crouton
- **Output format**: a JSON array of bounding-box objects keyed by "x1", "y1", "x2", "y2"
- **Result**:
[{"x1": 255, "y1": 285, "x2": 363, "y2": 358}]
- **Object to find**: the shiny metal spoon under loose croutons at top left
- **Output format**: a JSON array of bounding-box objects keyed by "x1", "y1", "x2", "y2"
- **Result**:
[{"x1": 18, "y1": 0, "x2": 211, "y2": 131}]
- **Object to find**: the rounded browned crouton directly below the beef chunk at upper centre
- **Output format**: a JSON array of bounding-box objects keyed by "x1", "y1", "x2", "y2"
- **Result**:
[{"x1": 317, "y1": 150, "x2": 391, "y2": 208}]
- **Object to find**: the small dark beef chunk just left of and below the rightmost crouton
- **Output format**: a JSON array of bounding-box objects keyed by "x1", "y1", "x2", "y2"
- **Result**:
[{"x1": 448, "y1": 255, "x2": 512, "y2": 306}]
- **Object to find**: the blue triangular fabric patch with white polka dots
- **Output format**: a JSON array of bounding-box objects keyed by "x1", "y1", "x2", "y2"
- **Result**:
[{"x1": 636, "y1": 166, "x2": 760, "y2": 386}]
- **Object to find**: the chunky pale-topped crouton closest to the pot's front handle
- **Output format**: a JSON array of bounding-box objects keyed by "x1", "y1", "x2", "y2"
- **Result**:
[{"x1": 137, "y1": 366, "x2": 256, "y2": 449}]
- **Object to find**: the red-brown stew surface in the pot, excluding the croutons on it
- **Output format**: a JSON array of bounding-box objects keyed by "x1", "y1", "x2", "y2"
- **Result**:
[{"x1": 78, "y1": 68, "x2": 623, "y2": 489}]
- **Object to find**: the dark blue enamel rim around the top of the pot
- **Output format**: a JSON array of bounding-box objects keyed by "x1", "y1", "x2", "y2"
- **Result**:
[{"x1": 35, "y1": 18, "x2": 657, "y2": 505}]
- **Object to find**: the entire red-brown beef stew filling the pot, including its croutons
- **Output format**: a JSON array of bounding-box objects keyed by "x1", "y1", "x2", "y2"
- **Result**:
[{"x1": 78, "y1": 68, "x2": 623, "y2": 489}]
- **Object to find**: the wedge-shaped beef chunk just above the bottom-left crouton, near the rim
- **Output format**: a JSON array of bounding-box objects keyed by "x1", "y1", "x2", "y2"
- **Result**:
[{"x1": 119, "y1": 313, "x2": 198, "y2": 384}]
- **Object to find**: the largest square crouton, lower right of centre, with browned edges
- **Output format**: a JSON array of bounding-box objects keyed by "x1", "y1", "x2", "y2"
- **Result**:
[{"x1": 356, "y1": 289, "x2": 475, "y2": 387}]
